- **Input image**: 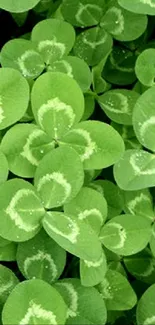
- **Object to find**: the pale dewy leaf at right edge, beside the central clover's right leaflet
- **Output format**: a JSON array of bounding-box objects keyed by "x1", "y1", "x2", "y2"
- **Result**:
[{"x1": 114, "y1": 149, "x2": 155, "y2": 191}]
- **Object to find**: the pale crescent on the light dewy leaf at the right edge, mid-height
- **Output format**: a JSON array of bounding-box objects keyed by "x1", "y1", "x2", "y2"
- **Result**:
[{"x1": 130, "y1": 152, "x2": 155, "y2": 176}]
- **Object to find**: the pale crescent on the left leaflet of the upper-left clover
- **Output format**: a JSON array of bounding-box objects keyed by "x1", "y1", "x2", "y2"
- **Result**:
[{"x1": 17, "y1": 50, "x2": 44, "y2": 77}]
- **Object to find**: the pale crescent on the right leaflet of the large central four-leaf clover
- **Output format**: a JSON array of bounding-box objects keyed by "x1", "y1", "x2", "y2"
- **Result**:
[{"x1": 71, "y1": 129, "x2": 97, "y2": 162}]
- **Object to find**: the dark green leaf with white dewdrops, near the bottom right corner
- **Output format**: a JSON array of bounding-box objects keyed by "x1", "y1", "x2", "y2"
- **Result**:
[{"x1": 98, "y1": 270, "x2": 137, "y2": 310}]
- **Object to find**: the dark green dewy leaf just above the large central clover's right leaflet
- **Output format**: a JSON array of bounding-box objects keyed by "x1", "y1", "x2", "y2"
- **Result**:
[{"x1": 98, "y1": 89, "x2": 139, "y2": 125}]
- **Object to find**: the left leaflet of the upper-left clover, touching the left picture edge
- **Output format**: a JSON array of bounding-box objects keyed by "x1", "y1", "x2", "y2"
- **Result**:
[{"x1": 0, "y1": 38, "x2": 44, "y2": 79}]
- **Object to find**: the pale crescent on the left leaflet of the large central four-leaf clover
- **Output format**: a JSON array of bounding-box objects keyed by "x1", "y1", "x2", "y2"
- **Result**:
[{"x1": 20, "y1": 130, "x2": 53, "y2": 166}]
